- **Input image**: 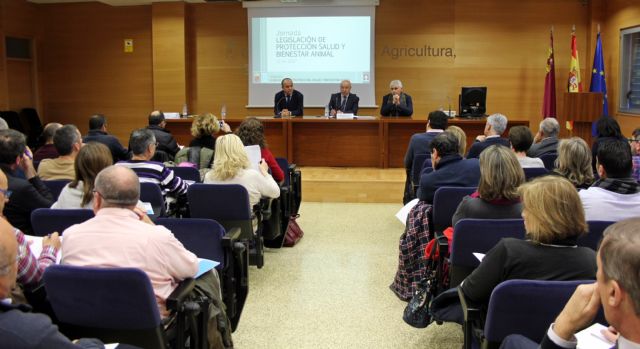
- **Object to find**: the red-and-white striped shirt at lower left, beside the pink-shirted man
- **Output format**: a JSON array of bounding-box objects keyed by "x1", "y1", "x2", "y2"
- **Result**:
[{"x1": 14, "y1": 228, "x2": 58, "y2": 285}]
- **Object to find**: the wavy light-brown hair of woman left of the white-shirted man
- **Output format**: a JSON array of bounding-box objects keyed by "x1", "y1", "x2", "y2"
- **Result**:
[{"x1": 550, "y1": 137, "x2": 594, "y2": 189}]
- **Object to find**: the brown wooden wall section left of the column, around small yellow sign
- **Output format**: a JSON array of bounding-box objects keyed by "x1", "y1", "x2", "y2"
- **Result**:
[{"x1": 41, "y1": 3, "x2": 153, "y2": 144}]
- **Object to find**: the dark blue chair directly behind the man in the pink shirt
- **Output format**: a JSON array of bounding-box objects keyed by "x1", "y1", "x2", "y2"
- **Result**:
[{"x1": 44, "y1": 265, "x2": 208, "y2": 349}]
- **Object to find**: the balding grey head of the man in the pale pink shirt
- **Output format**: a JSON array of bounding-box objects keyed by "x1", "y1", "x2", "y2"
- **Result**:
[{"x1": 95, "y1": 165, "x2": 140, "y2": 208}]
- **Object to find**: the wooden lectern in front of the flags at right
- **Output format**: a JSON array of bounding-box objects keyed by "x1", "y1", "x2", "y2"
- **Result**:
[{"x1": 558, "y1": 92, "x2": 603, "y2": 146}]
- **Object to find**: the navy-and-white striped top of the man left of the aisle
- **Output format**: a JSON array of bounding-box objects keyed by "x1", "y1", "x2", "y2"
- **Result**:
[{"x1": 117, "y1": 160, "x2": 189, "y2": 198}]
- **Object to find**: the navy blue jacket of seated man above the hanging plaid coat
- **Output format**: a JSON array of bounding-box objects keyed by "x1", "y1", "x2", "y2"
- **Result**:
[{"x1": 418, "y1": 153, "x2": 480, "y2": 204}]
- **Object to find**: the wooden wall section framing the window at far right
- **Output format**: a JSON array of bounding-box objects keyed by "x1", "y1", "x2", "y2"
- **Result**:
[{"x1": 602, "y1": 0, "x2": 640, "y2": 137}]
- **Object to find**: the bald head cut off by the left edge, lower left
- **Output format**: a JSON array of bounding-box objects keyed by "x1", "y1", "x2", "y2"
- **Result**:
[{"x1": 0, "y1": 218, "x2": 18, "y2": 299}]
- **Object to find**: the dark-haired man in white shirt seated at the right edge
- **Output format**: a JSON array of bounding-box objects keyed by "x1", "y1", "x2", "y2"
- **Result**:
[{"x1": 580, "y1": 139, "x2": 640, "y2": 221}]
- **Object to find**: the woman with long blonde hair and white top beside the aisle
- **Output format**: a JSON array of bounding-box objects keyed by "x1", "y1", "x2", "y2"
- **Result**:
[{"x1": 204, "y1": 134, "x2": 280, "y2": 207}]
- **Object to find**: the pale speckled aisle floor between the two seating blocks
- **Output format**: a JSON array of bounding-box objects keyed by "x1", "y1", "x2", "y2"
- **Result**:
[{"x1": 233, "y1": 202, "x2": 463, "y2": 349}]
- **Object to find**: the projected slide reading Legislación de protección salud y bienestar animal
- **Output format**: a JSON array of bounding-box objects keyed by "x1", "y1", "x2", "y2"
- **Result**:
[{"x1": 251, "y1": 16, "x2": 371, "y2": 84}]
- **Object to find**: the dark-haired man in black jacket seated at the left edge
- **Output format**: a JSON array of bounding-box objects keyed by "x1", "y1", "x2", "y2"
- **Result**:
[{"x1": 0, "y1": 129, "x2": 53, "y2": 234}]
